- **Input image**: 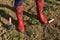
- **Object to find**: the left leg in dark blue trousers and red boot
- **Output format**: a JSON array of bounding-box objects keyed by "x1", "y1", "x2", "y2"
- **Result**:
[{"x1": 15, "y1": 0, "x2": 24, "y2": 32}]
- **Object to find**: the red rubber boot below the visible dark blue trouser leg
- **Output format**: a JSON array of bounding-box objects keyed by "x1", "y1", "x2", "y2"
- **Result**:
[{"x1": 16, "y1": 6, "x2": 24, "y2": 32}]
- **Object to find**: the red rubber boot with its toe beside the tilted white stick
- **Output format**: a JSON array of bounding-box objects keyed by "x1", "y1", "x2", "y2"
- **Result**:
[{"x1": 36, "y1": 0, "x2": 47, "y2": 23}]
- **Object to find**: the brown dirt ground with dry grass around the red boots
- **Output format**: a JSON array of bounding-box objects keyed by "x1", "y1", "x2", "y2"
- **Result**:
[{"x1": 0, "y1": 0, "x2": 60, "y2": 40}]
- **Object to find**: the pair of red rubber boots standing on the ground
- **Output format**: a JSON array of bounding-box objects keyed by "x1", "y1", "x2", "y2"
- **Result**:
[{"x1": 16, "y1": 0, "x2": 47, "y2": 32}]
